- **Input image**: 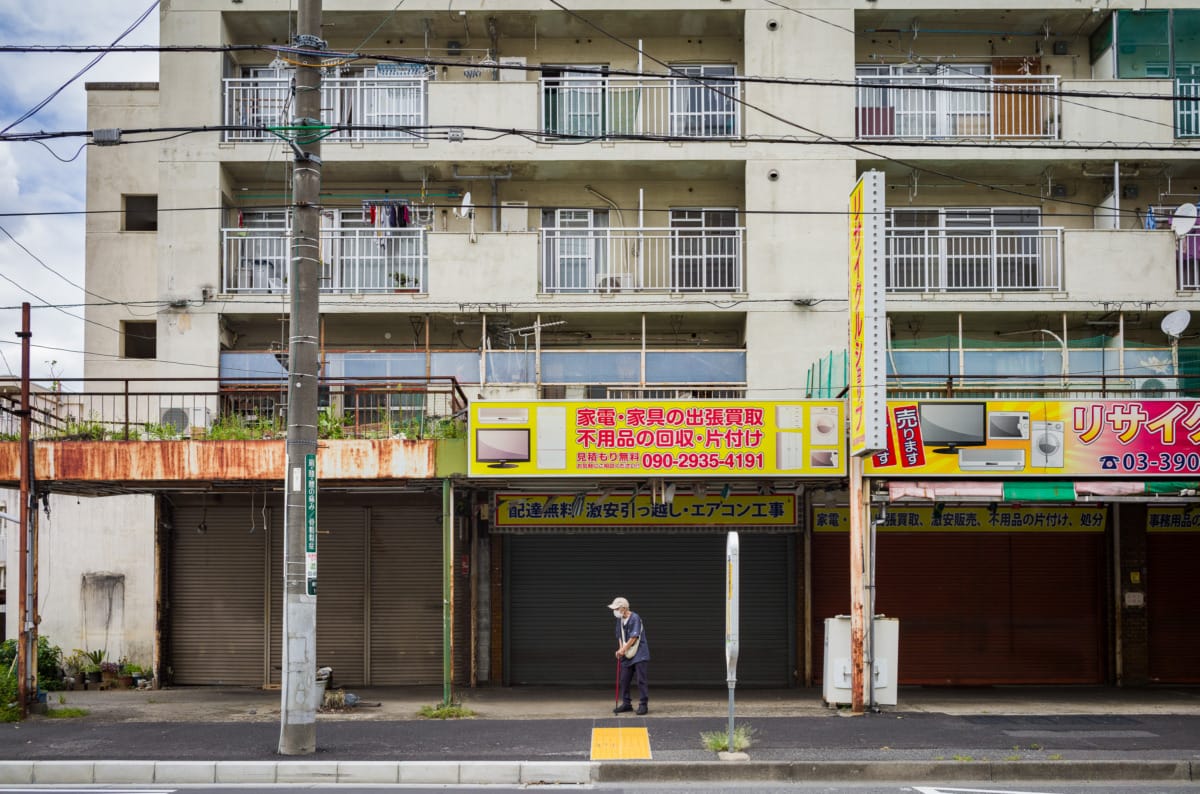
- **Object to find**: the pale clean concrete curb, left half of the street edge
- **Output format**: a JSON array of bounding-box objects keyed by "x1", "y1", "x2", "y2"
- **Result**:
[{"x1": 0, "y1": 760, "x2": 599, "y2": 786}]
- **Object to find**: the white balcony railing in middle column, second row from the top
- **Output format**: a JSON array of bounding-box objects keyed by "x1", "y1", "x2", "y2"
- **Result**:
[{"x1": 541, "y1": 227, "x2": 745, "y2": 293}]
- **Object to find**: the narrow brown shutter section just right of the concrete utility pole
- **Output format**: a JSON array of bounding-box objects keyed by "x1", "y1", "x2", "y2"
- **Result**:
[{"x1": 317, "y1": 500, "x2": 367, "y2": 686}]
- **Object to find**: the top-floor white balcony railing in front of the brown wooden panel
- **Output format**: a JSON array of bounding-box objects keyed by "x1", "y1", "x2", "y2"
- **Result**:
[{"x1": 854, "y1": 74, "x2": 1060, "y2": 140}]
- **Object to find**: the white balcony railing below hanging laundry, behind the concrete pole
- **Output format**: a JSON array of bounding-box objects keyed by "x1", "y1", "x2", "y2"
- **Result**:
[{"x1": 221, "y1": 228, "x2": 428, "y2": 293}]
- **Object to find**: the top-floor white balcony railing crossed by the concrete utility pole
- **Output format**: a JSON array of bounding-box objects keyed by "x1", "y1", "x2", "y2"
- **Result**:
[{"x1": 224, "y1": 74, "x2": 428, "y2": 142}]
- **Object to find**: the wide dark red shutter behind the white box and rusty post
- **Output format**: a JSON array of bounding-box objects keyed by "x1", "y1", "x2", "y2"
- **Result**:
[{"x1": 812, "y1": 533, "x2": 1104, "y2": 685}]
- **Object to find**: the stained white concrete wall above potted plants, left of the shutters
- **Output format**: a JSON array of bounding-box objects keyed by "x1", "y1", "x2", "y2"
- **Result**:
[{"x1": 0, "y1": 491, "x2": 157, "y2": 666}]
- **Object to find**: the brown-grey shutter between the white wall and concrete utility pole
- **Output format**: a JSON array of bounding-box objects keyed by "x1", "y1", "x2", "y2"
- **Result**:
[{"x1": 168, "y1": 498, "x2": 266, "y2": 686}]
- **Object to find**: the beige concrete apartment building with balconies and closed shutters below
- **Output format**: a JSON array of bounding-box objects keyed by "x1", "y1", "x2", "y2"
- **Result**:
[{"x1": 56, "y1": 0, "x2": 1200, "y2": 686}]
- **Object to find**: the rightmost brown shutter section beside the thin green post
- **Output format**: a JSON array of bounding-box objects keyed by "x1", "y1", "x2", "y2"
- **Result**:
[{"x1": 371, "y1": 495, "x2": 442, "y2": 685}]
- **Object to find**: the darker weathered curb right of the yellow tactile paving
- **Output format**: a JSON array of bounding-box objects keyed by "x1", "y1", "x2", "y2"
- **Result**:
[{"x1": 596, "y1": 760, "x2": 1200, "y2": 783}]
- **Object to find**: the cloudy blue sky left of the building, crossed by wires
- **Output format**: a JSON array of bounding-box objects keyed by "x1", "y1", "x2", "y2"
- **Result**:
[{"x1": 0, "y1": 0, "x2": 158, "y2": 391}]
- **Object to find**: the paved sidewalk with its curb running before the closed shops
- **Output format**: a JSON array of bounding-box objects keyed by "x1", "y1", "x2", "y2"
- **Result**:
[{"x1": 0, "y1": 687, "x2": 1200, "y2": 784}]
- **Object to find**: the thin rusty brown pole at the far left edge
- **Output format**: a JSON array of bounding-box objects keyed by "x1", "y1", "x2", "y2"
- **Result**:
[{"x1": 17, "y1": 303, "x2": 37, "y2": 720}]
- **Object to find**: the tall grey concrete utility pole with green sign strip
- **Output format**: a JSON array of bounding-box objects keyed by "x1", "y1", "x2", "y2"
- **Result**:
[{"x1": 280, "y1": 0, "x2": 325, "y2": 756}]
